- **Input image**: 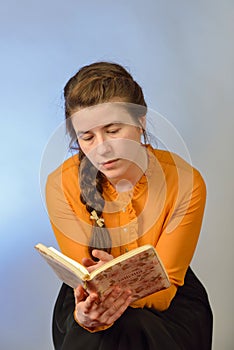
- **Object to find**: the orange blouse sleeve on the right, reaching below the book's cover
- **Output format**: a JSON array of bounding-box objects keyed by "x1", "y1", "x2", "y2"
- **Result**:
[{"x1": 132, "y1": 169, "x2": 206, "y2": 310}]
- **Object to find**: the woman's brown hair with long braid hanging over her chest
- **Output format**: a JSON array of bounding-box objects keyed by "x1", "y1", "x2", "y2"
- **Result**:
[{"x1": 64, "y1": 62, "x2": 147, "y2": 256}]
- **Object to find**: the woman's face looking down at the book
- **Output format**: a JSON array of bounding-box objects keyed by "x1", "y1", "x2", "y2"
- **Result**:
[{"x1": 72, "y1": 102, "x2": 145, "y2": 184}]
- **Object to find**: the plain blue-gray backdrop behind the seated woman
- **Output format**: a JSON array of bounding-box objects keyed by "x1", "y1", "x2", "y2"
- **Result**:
[{"x1": 0, "y1": 0, "x2": 234, "y2": 350}]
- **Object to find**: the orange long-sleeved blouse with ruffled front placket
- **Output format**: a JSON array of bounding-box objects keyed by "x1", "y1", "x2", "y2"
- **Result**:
[{"x1": 46, "y1": 146, "x2": 206, "y2": 310}]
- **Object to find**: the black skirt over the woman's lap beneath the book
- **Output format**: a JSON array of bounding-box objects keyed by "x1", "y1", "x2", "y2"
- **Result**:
[{"x1": 53, "y1": 268, "x2": 213, "y2": 350}]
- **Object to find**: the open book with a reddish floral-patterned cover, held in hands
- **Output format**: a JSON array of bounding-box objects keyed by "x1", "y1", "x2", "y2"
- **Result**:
[{"x1": 35, "y1": 243, "x2": 170, "y2": 301}]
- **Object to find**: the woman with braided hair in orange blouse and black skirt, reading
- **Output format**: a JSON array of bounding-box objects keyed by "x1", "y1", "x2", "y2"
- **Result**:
[{"x1": 46, "y1": 62, "x2": 212, "y2": 350}]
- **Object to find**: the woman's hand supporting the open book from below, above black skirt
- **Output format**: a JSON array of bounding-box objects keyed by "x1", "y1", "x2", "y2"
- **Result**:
[{"x1": 75, "y1": 286, "x2": 131, "y2": 330}]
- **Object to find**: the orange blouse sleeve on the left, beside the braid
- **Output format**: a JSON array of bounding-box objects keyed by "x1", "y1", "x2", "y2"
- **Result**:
[{"x1": 46, "y1": 169, "x2": 90, "y2": 263}]
